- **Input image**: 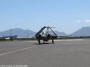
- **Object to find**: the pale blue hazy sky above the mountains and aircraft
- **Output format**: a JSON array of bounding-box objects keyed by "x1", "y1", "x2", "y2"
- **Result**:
[{"x1": 0, "y1": 0, "x2": 90, "y2": 33}]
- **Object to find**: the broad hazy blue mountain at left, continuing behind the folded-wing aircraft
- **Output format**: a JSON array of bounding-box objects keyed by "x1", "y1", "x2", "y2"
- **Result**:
[{"x1": 0, "y1": 28, "x2": 66, "y2": 38}]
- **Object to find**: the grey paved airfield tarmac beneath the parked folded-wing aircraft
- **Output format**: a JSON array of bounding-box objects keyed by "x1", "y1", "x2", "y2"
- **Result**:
[{"x1": 0, "y1": 39, "x2": 90, "y2": 67}]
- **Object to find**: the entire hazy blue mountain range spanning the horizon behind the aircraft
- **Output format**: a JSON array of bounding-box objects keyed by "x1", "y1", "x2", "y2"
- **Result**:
[{"x1": 0, "y1": 27, "x2": 90, "y2": 38}]
